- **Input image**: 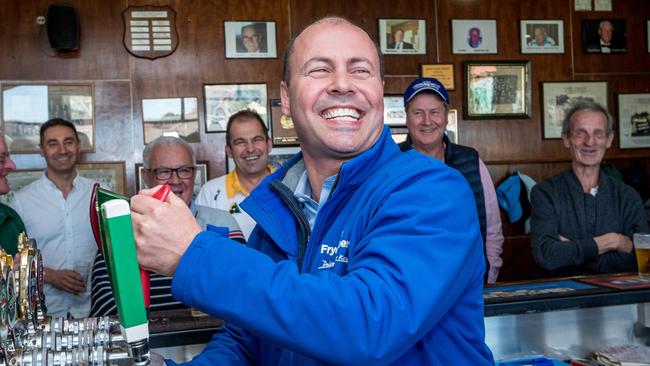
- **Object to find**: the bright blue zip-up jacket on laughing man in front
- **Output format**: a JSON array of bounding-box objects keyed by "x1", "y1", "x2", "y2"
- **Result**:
[{"x1": 167, "y1": 128, "x2": 494, "y2": 366}]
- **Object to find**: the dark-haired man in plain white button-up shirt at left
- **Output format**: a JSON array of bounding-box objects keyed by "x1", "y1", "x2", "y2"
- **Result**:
[{"x1": 11, "y1": 118, "x2": 97, "y2": 318}]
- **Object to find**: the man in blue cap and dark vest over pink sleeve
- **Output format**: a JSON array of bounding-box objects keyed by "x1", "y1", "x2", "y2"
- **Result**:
[{"x1": 400, "y1": 78, "x2": 503, "y2": 283}]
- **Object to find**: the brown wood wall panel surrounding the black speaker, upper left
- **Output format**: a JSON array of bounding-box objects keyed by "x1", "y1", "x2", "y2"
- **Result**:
[{"x1": 0, "y1": 0, "x2": 129, "y2": 80}]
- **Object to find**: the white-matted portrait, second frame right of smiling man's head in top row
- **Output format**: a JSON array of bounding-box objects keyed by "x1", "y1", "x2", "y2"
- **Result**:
[{"x1": 451, "y1": 19, "x2": 498, "y2": 54}]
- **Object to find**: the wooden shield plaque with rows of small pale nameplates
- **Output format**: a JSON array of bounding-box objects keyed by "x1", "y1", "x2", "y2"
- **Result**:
[{"x1": 122, "y1": 5, "x2": 178, "y2": 60}]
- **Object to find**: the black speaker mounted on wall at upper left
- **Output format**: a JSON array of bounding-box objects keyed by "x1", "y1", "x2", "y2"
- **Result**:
[{"x1": 47, "y1": 5, "x2": 79, "y2": 51}]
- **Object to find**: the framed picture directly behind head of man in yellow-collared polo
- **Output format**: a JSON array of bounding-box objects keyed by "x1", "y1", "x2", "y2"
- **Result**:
[{"x1": 203, "y1": 83, "x2": 269, "y2": 133}]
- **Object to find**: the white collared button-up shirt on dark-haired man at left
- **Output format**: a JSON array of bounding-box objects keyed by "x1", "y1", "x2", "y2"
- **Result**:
[{"x1": 10, "y1": 173, "x2": 97, "y2": 318}]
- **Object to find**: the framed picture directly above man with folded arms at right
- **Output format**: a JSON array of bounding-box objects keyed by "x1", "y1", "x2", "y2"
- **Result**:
[{"x1": 540, "y1": 81, "x2": 607, "y2": 139}]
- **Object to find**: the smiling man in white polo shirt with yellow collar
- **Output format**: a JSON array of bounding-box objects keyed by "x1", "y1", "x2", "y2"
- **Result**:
[{"x1": 196, "y1": 110, "x2": 273, "y2": 240}]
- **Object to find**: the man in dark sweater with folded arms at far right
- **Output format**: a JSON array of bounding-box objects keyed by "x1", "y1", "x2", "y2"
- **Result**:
[{"x1": 531, "y1": 102, "x2": 648, "y2": 276}]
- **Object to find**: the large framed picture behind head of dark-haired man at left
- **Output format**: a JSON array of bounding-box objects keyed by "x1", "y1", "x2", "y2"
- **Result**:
[{"x1": 2, "y1": 84, "x2": 95, "y2": 154}]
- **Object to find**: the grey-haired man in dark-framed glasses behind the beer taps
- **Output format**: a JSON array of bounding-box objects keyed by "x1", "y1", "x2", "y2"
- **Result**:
[{"x1": 91, "y1": 136, "x2": 244, "y2": 316}]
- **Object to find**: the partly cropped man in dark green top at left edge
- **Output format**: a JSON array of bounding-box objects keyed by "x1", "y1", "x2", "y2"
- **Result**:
[{"x1": 0, "y1": 134, "x2": 25, "y2": 255}]
